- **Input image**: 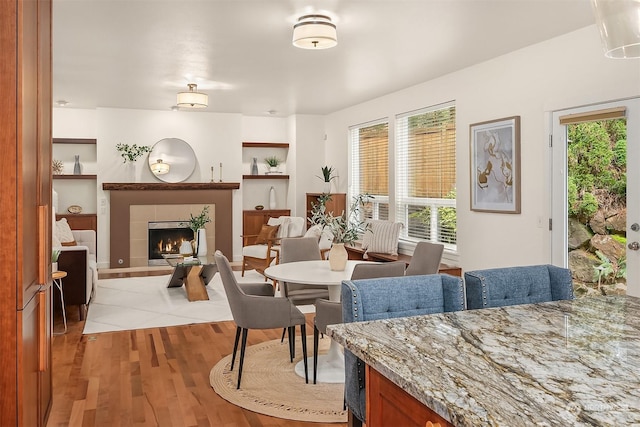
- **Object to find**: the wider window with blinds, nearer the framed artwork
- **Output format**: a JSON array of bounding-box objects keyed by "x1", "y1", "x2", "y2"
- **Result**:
[{"x1": 395, "y1": 103, "x2": 457, "y2": 247}]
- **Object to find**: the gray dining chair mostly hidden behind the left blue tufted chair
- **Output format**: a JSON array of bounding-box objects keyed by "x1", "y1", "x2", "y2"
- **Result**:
[{"x1": 313, "y1": 261, "x2": 405, "y2": 384}]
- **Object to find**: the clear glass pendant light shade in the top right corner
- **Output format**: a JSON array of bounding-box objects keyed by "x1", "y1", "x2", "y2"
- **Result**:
[{"x1": 591, "y1": 0, "x2": 640, "y2": 59}]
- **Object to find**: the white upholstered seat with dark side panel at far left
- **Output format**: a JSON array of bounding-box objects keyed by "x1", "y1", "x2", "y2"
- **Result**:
[{"x1": 54, "y1": 230, "x2": 98, "y2": 320}]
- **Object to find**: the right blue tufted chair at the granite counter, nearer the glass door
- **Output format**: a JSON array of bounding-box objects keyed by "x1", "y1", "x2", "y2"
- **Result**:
[{"x1": 464, "y1": 265, "x2": 573, "y2": 309}]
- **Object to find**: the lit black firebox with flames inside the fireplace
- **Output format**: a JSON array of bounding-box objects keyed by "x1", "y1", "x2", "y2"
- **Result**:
[{"x1": 148, "y1": 221, "x2": 193, "y2": 265}]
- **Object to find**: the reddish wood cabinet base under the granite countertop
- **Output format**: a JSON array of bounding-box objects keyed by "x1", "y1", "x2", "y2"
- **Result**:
[{"x1": 366, "y1": 365, "x2": 453, "y2": 427}]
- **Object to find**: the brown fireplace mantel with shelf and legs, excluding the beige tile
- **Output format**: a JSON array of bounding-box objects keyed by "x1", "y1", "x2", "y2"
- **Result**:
[{"x1": 102, "y1": 182, "x2": 240, "y2": 268}]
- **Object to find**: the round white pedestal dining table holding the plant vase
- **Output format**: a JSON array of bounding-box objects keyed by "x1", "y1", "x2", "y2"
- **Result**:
[{"x1": 264, "y1": 260, "x2": 367, "y2": 383}]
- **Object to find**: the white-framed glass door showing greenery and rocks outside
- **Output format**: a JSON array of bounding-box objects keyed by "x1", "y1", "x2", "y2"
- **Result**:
[{"x1": 551, "y1": 99, "x2": 640, "y2": 296}]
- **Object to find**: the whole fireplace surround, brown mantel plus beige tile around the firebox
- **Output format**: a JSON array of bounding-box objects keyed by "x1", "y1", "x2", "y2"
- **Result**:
[{"x1": 102, "y1": 182, "x2": 240, "y2": 268}]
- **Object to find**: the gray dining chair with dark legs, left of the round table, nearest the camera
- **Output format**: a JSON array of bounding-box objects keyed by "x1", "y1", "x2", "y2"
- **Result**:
[{"x1": 214, "y1": 251, "x2": 309, "y2": 389}]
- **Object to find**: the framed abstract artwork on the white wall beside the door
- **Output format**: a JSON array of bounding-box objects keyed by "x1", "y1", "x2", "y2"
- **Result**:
[{"x1": 469, "y1": 116, "x2": 520, "y2": 214}]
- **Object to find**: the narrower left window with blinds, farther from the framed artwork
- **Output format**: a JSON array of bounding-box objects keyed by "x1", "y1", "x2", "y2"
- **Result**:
[{"x1": 349, "y1": 120, "x2": 389, "y2": 219}]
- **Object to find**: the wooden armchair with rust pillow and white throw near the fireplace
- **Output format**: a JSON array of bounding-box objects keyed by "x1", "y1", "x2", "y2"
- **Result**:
[{"x1": 242, "y1": 216, "x2": 306, "y2": 280}]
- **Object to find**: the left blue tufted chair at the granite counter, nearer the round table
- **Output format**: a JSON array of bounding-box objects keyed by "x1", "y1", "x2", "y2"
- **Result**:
[{"x1": 342, "y1": 274, "x2": 464, "y2": 425}]
